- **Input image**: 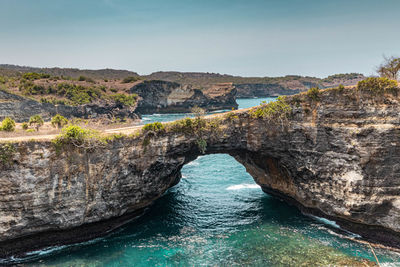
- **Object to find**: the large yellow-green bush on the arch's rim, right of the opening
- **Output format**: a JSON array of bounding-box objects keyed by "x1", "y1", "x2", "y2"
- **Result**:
[{"x1": 250, "y1": 97, "x2": 292, "y2": 120}]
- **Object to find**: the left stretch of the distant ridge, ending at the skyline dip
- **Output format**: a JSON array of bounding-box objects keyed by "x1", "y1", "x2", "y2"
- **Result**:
[{"x1": 0, "y1": 64, "x2": 139, "y2": 80}]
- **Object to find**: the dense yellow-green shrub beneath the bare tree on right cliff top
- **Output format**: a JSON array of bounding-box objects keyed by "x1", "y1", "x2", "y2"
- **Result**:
[{"x1": 357, "y1": 77, "x2": 399, "y2": 94}]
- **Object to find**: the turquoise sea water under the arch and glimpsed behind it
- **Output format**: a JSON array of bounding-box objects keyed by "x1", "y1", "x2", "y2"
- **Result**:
[{"x1": 10, "y1": 98, "x2": 400, "y2": 266}]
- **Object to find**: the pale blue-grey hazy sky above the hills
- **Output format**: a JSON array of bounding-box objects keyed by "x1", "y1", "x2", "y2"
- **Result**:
[{"x1": 0, "y1": 0, "x2": 400, "y2": 77}]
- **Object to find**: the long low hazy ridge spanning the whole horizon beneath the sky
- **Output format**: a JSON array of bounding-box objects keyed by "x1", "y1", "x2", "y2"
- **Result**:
[{"x1": 0, "y1": 64, "x2": 365, "y2": 97}]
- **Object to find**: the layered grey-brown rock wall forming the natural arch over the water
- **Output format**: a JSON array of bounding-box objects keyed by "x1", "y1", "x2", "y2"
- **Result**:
[{"x1": 0, "y1": 89, "x2": 400, "y2": 257}]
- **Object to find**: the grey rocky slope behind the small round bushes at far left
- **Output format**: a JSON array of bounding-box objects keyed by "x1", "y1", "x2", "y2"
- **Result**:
[{"x1": 0, "y1": 91, "x2": 140, "y2": 122}]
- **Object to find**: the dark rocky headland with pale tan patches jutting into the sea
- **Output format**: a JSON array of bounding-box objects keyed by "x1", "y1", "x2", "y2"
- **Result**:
[{"x1": 131, "y1": 80, "x2": 238, "y2": 114}]
